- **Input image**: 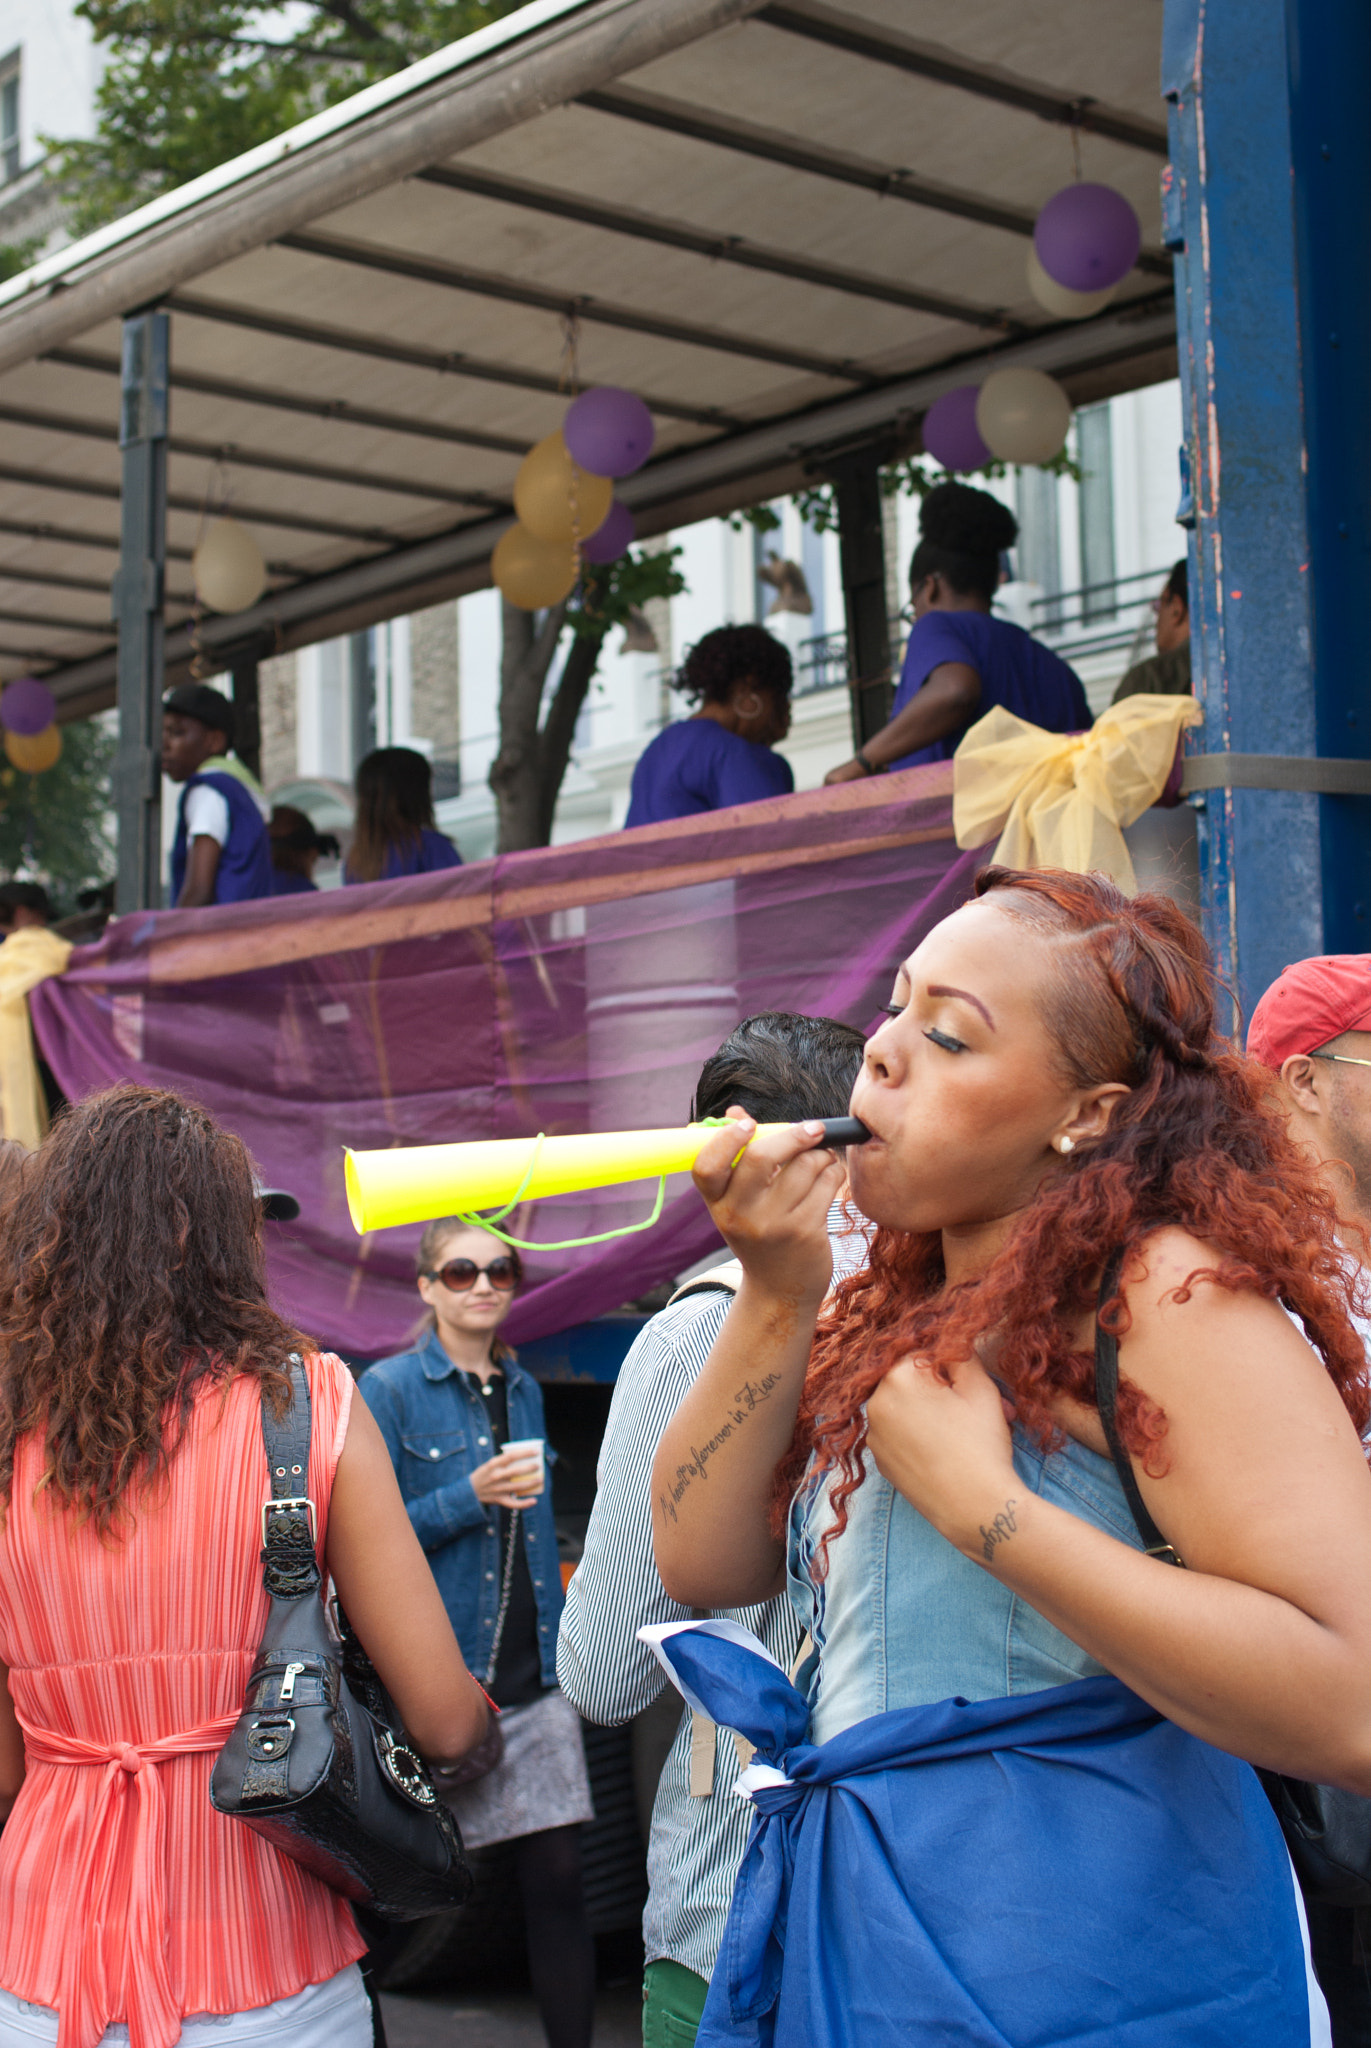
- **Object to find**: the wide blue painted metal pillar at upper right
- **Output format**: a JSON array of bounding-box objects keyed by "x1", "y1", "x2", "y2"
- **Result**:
[{"x1": 1162, "y1": 0, "x2": 1371, "y2": 1012}]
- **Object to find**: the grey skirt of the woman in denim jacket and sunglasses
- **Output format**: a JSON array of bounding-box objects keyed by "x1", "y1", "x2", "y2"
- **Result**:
[{"x1": 443, "y1": 1690, "x2": 594, "y2": 1849}]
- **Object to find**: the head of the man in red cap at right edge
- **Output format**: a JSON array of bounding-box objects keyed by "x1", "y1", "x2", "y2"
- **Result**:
[{"x1": 1248, "y1": 952, "x2": 1371, "y2": 1236}]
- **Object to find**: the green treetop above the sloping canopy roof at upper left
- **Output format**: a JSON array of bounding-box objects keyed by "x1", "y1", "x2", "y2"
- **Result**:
[{"x1": 45, "y1": 0, "x2": 521, "y2": 236}]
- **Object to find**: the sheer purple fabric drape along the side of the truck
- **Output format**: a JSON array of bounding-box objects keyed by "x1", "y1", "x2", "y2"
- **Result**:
[{"x1": 31, "y1": 764, "x2": 984, "y2": 1358}]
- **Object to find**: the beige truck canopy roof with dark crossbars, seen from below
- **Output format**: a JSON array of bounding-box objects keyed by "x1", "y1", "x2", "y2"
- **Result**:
[{"x1": 0, "y1": 0, "x2": 1174, "y2": 713}]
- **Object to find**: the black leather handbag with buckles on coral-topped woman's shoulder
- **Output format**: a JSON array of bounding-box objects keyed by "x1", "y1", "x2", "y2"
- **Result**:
[{"x1": 209, "y1": 1358, "x2": 471, "y2": 1921}]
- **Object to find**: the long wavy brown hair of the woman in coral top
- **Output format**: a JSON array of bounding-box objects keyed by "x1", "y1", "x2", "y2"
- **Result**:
[{"x1": 0, "y1": 1085, "x2": 311, "y2": 1534}]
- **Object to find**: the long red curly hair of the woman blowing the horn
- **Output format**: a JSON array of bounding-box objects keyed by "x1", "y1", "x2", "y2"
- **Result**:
[{"x1": 773, "y1": 868, "x2": 1371, "y2": 1536}]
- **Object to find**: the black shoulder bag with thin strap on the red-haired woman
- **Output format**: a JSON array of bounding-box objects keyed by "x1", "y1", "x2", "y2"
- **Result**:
[{"x1": 1094, "y1": 1251, "x2": 1371, "y2": 1907}]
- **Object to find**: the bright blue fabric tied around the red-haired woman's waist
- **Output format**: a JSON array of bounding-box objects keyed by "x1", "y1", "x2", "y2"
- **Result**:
[{"x1": 650, "y1": 1622, "x2": 1326, "y2": 2048}]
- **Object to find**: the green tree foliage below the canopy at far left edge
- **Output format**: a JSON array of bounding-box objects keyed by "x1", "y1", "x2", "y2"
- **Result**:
[{"x1": 0, "y1": 719, "x2": 115, "y2": 909}]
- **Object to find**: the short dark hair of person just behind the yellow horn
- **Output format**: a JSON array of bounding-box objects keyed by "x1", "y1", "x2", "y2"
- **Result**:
[{"x1": 691, "y1": 1010, "x2": 867, "y2": 1124}]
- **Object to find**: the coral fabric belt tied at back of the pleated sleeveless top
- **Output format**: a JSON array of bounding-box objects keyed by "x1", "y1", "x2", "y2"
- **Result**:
[{"x1": 25, "y1": 1712, "x2": 238, "y2": 2048}]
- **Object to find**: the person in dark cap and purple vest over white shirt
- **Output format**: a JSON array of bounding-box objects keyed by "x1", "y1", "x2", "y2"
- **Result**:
[{"x1": 162, "y1": 682, "x2": 271, "y2": 909}]
